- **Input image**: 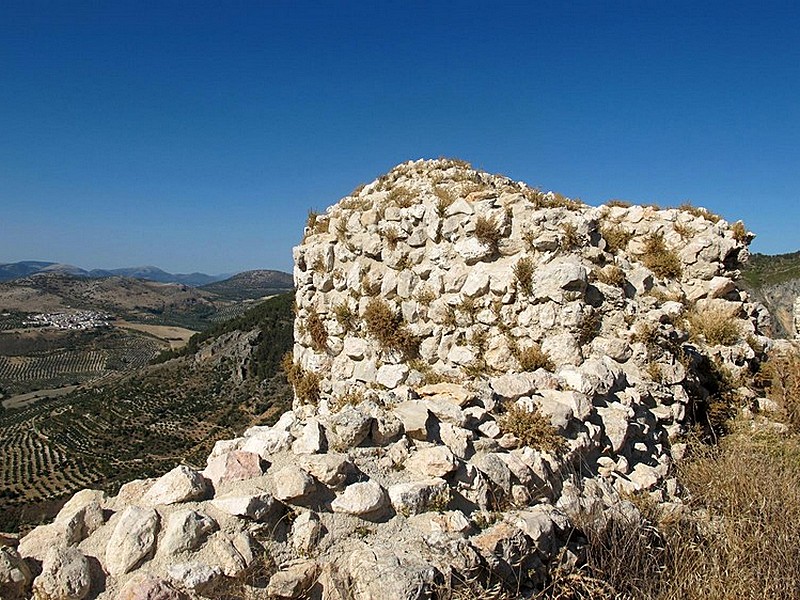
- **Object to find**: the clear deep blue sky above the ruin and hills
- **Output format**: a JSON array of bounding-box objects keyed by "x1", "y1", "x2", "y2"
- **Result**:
[{"x1": 0, "y1": 0, "x2": 800, "y2": 273}]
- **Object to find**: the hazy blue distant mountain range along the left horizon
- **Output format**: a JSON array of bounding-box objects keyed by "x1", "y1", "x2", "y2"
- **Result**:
[{"x1": 0, "y1": 260, "x2": 234, "y2": 287}]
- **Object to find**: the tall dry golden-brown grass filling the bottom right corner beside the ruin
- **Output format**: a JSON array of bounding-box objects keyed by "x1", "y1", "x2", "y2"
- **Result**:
[{"x1": 560, "y1": 426, "x2": 800, "y2": 600}]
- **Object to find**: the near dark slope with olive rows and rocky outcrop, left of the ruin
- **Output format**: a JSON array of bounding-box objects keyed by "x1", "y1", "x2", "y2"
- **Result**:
[{"x1": 0, "y1": 295, "x2": 292, "y2": 531}]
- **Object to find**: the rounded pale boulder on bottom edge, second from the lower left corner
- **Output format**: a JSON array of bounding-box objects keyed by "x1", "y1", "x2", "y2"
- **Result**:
[{"x1": 33, "y1": 546, "x2": 92, "y2": 600}]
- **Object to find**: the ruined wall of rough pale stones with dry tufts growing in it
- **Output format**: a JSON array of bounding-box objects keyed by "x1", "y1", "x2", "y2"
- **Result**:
[{"x1": 0, "y1": 159, "x2": 772, "y2": 600}]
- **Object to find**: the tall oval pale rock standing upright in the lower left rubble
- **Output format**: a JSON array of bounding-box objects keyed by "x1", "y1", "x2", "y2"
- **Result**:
[{"x1": 105, "y1": 506, "x2": 159, "y2": 577}]
